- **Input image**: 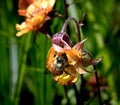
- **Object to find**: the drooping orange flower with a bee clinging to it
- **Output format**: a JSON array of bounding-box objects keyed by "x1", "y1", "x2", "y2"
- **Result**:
[{"x1": 46, "y1": 39, "x2": 101, "y2": 85}]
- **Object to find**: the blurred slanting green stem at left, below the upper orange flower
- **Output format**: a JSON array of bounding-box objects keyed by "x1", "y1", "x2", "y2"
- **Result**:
[{"x1": 14, "y1": 35, "x2": 31, "y2": 105}]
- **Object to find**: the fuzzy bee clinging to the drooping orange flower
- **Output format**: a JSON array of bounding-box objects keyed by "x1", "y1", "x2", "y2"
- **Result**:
[{"x1": 47, "y1": 46, "x2": 68, "y2": 76}]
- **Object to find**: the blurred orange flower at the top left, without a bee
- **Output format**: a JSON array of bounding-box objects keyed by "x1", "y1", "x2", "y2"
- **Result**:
[{"x1": 16, "y1": 0, "x2": 55, "y2": 36}]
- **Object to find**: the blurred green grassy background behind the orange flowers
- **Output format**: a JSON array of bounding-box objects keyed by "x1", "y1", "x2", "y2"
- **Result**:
[{"x1": 0, "y1": 0, "x2": 120, "y2": 105}]
